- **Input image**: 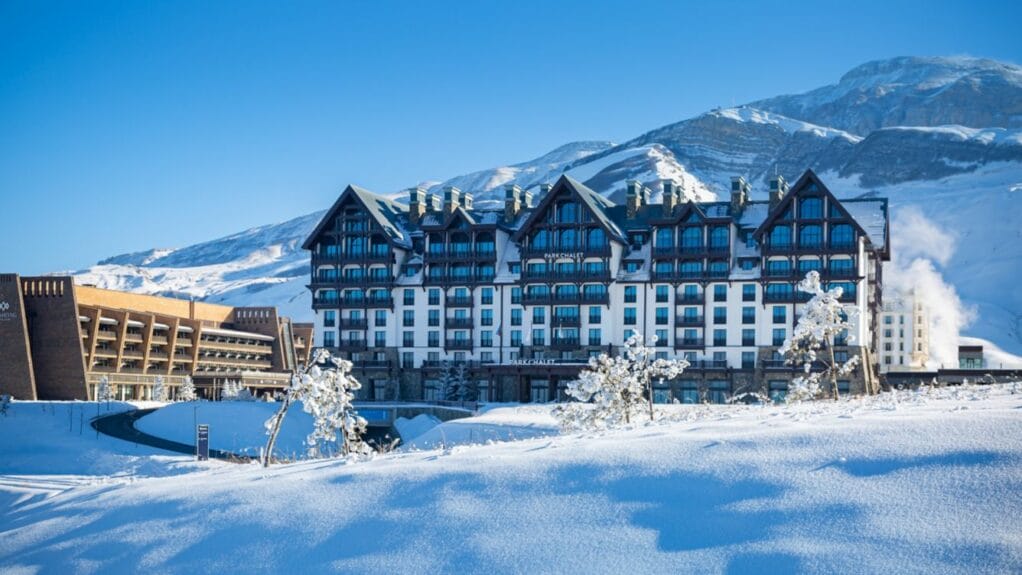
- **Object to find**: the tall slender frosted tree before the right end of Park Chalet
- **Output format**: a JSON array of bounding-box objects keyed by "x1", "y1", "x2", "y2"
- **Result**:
[{"x1": 781, "y1": 271, "x2": 860, "y2": 401}]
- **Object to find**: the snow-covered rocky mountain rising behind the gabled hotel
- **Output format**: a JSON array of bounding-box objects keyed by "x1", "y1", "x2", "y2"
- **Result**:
[{"x1": 72, "y1": 58, "x2": 1022, "y2": 352}]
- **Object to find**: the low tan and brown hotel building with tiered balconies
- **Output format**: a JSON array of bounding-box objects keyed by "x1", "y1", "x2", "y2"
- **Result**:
[{"x1": 0, "y1": 274, "x2": 313, "y2": 399}]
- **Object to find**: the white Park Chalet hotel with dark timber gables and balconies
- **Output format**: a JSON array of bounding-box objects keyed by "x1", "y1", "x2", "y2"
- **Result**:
[{"x1": 304, "y1": 172, "x2": 890, "y2": 402}]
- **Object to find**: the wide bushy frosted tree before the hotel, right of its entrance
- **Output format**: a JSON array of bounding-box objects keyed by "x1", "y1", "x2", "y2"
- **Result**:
[{"x1": 554, "y1": 335, "x2": 689, "y2": 430}]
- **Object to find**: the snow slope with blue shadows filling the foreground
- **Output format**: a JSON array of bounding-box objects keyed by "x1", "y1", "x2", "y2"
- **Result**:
[{"x1": 0, "y1": 385, "x2": 1022, "y2": 574}]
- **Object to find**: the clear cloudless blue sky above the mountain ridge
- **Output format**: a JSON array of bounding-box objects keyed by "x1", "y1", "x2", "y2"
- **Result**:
[{"x1": 0, "y1": 0, "x2": 1022, "y2": 274}]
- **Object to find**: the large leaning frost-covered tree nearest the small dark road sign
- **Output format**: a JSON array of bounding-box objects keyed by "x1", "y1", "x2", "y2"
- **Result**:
[{"x1": 263, "y1": 349, "x2": 372, "y2": 467}]
